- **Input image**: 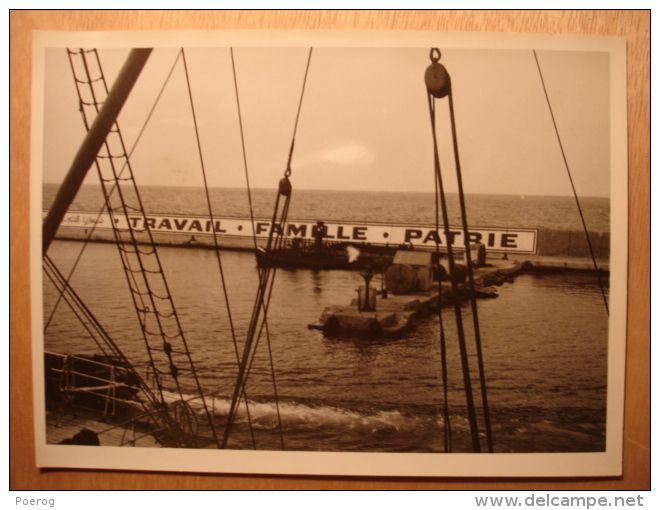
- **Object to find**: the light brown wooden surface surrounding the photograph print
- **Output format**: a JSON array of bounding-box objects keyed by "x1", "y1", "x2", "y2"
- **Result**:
[{"x1": 9, "y1": 11, "x2": 651, "y2": 490}]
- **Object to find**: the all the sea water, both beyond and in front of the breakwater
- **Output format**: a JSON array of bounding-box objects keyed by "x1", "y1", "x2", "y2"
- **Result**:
[{"x1": 43, "y1": 185, "x2": 610, "y2": 453}]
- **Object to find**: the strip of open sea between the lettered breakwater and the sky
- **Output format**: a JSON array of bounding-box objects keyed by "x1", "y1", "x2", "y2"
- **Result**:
[{"x1": 43, "y1": 184, "x2": 610, "y2": 232}]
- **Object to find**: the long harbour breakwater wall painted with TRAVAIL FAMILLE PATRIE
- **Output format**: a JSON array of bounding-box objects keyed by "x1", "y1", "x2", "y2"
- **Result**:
[{"x1": 49, "y1": 212, "x2": 610, "y2": 260}]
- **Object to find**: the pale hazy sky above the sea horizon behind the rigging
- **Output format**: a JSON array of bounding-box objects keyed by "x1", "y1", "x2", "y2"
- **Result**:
[{"x1": 43, "y1": 43, "x2": 611, "y2": 197}]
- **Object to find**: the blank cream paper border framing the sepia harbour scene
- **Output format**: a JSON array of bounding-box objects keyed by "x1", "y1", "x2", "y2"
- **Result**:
[{"x1": 30, "y1": 30, "x2": 628, "y2": 477}]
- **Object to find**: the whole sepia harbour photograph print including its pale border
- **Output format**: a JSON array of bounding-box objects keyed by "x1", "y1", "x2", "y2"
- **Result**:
[{"x1": 31, "y1": 31, "x2": 627, "y2": 476}]
